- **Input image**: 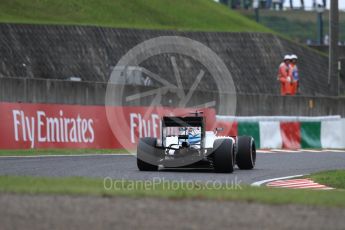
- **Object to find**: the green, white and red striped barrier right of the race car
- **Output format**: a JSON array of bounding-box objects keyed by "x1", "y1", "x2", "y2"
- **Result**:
[{"x1": 217, "y1": 118, "x2": 345, "y2": 149}]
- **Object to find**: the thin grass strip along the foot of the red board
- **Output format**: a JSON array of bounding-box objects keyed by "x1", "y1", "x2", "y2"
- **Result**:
[{"x1": 0, "y1": 149, "x2": 128, "y2": 156}]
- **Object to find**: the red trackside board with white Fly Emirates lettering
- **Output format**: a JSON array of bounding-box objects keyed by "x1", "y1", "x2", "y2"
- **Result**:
[{"x1": 0, "y1": 103, "x2": 215, "y2": 149}]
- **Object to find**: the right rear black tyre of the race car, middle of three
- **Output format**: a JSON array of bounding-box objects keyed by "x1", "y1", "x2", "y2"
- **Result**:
[{"x1": 213, "y1": 139, "x2": 234, "y2": 173}]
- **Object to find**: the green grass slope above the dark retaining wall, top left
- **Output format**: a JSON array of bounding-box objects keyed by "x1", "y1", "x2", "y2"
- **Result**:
[{"x1": 0, "y1": 0, "x2": 272, "y2": 32}]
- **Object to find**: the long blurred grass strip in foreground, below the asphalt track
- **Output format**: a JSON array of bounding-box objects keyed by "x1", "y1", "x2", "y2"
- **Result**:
[{"x1": 0, "y1": 176, "x2": 345, "y2": 207}]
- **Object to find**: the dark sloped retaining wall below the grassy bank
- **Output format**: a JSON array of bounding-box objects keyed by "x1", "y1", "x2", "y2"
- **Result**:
[{"x1": 0, "y1": 24, "x2": 333, "y2": 95}]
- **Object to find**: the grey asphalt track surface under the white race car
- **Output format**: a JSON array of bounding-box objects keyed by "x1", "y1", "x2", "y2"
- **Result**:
[{"x1": 0, "y1": 152, "x2": 345, "y2": 184}]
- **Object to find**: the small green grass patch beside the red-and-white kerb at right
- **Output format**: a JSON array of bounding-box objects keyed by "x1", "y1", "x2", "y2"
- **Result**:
[{"x1": 308, "y1": 170, "x2": 345, "y2": 189}]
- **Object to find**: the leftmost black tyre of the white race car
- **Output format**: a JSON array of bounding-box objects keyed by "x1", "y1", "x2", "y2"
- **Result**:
[{"x1": 137, "y1": 137, "x2": 158, "y2": 171}]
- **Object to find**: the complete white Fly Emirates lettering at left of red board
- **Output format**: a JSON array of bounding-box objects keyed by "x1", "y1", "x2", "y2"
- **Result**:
[{"x1": 12, "y1": 110, "x2": 95, "y2": 148}]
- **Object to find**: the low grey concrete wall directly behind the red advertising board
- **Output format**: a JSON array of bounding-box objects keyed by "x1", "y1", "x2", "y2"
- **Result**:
[{"x1": 0, "y1": 78, "x2": 345, "y2": 117}]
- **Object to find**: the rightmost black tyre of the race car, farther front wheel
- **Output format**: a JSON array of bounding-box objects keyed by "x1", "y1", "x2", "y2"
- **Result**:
[{"x1": 236, "y1": 136, "x2": 256, "y2": 169}]
